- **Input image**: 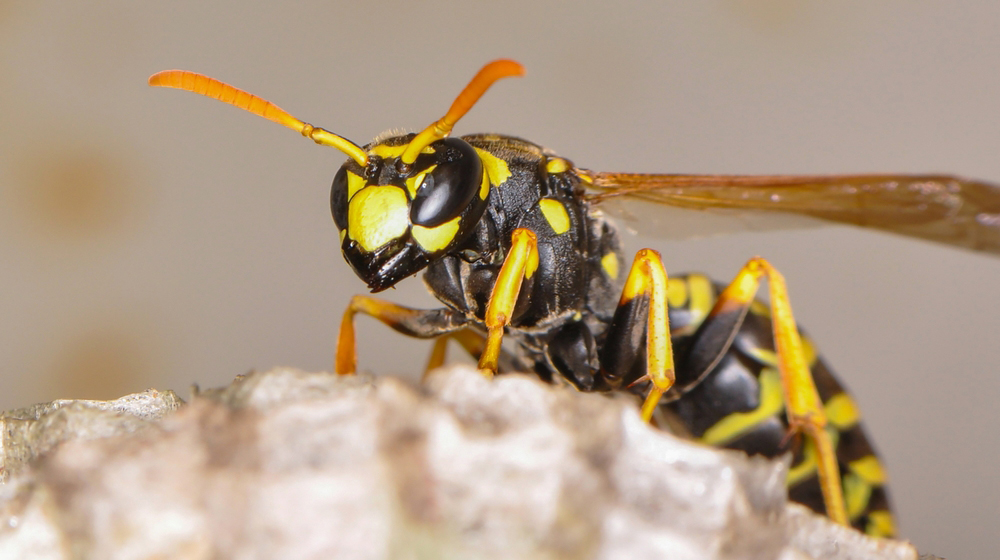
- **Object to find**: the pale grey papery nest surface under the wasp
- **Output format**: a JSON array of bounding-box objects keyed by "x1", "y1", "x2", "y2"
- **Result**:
[{"x1": 0, "y1": 367, "x2": 917, "y2": 560}]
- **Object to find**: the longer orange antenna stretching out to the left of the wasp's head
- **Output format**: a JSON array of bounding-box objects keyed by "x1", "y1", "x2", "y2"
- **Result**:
[{"x1": 149, "y1": 70, "x2": 368, "y2": 167}]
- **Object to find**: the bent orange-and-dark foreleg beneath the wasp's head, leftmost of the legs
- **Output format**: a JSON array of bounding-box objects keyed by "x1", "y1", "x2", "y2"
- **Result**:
[{"x1": 334, "y1": 295, "x2": 466, "y2": 375}]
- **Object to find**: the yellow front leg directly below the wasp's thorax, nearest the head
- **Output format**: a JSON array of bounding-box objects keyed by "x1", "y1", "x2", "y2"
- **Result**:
[{"x1": 479, "y1": 228, "x2": 538, "y2": 377}]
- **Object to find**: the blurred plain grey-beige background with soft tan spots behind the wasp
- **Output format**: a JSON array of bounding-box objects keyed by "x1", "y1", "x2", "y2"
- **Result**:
[{"x1": 0, "y1": 0, "x2": 1000, "y2": 558}]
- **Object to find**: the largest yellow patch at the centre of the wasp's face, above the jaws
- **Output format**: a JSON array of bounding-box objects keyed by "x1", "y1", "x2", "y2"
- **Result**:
[{"x1": 347, "y1": 185, "x2": 410, "y2": 252}]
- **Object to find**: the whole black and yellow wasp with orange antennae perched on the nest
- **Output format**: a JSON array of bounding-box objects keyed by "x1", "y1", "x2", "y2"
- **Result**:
[{"x1": 149, "y1": 60, "x2": 1000, "y2": 536}]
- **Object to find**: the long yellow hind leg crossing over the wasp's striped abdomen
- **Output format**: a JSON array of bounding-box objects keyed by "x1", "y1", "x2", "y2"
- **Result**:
[{"x1": 709, "y1": 257, "x2": 848, "y2": 525}]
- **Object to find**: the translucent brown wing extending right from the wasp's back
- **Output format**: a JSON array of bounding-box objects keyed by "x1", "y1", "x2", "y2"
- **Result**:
[{"x1": 577, "y1": 170, "x2": 1000, "y2": 255}]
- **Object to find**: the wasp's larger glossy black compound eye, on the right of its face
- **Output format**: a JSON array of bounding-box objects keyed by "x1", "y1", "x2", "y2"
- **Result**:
[{"x1": 410, "y1": 138, "x2": 483, "y2": 227}]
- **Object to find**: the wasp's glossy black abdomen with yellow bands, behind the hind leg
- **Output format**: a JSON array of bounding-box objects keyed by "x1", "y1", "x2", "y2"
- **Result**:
[{"x1": 662, "y1": 274, "x2": 895, "y2": 536}]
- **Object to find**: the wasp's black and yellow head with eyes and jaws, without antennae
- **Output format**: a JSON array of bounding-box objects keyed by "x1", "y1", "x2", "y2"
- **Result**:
[{"x1": 330, "y1": 135, "x2": 489, "y2": 291}]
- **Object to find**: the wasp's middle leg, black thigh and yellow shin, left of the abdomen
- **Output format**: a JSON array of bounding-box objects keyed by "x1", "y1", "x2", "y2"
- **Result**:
[{"x1": 601, "y1": 249, "x2": 674, "y2": 422}]
